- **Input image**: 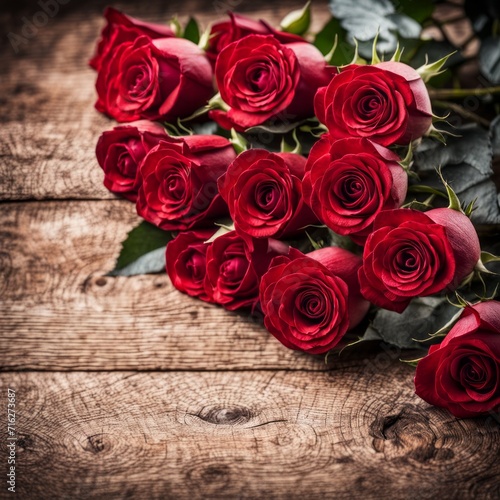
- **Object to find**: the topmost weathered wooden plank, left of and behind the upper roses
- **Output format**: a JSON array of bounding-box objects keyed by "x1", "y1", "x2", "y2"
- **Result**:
[{"x1": 0, "y1": 0, "x2": 327, "y2": 200}]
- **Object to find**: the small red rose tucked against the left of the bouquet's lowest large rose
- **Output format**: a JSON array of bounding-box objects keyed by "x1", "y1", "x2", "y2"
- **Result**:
[{"x1": 205, "y1": 231, "x2": 290, "y2": 311}]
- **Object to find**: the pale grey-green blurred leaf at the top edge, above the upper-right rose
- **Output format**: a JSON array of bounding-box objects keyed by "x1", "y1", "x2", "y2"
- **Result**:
[{"x1": 329, "y1": 0, "x2": 422, "y2": 58}]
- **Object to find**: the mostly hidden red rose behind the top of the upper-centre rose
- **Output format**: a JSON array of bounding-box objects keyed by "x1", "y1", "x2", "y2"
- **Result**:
[{"x1": 207, "y1": 12, "x2": 304, "y2": 65}]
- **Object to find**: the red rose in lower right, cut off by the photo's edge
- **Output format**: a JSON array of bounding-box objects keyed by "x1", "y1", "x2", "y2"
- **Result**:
[{"x1": 415, "y1": 301, "x2": 500, "y2": 418}]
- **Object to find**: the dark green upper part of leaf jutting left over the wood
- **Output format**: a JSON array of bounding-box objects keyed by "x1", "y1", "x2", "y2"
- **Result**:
[{"x1": 112, "y1": 221, "x2": 174, "y2": 273}]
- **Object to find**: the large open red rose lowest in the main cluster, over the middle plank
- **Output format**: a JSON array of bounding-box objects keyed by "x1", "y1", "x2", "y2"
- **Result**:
[{"x1": 260, "y1": 247, "x2": 369, "y2": 354}]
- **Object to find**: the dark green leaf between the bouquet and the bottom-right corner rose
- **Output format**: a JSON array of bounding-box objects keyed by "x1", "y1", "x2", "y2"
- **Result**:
[{"x1": 364, "y1": 297, "x2": 457, "y2": 349}]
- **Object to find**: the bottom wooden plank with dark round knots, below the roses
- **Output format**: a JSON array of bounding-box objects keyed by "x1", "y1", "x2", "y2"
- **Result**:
[{"x1": 0, "y1": 368, "x2": 500, "y2": 499}]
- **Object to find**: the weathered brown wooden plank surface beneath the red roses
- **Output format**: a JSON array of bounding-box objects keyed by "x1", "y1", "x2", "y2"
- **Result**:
[{"x1": 0, "y1": 0, "x2": 500, "y2": 499}]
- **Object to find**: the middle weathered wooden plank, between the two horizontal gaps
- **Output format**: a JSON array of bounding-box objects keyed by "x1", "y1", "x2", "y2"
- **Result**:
[{"x1": 0, "y1": 200, "x2": 356, "y2": 370}]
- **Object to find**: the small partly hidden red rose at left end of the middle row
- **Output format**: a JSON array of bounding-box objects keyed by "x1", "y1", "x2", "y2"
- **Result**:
[{"x1": 96, "y1": 120, "x2": 167, "y2": 201}]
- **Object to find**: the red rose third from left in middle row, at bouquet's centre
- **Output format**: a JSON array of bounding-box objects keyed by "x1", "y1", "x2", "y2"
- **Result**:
[{"x1": 218, "y1": 149, "x2": 317, "y2": 238}]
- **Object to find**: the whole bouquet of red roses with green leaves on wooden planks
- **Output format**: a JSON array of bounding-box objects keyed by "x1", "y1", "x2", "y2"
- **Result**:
[{"x1": 90, "y1": 2, "x2": 500, "y2": 417}]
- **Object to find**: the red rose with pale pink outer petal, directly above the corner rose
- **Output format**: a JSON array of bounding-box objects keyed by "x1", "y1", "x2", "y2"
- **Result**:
[{"x1": 359, "y1": 208, "x2": 481, "y2": 312}]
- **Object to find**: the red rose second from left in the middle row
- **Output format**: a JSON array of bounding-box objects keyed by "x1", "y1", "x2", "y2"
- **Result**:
[{"x1": 137, "y1": 135, "x2": 236, "y2": 230}]
